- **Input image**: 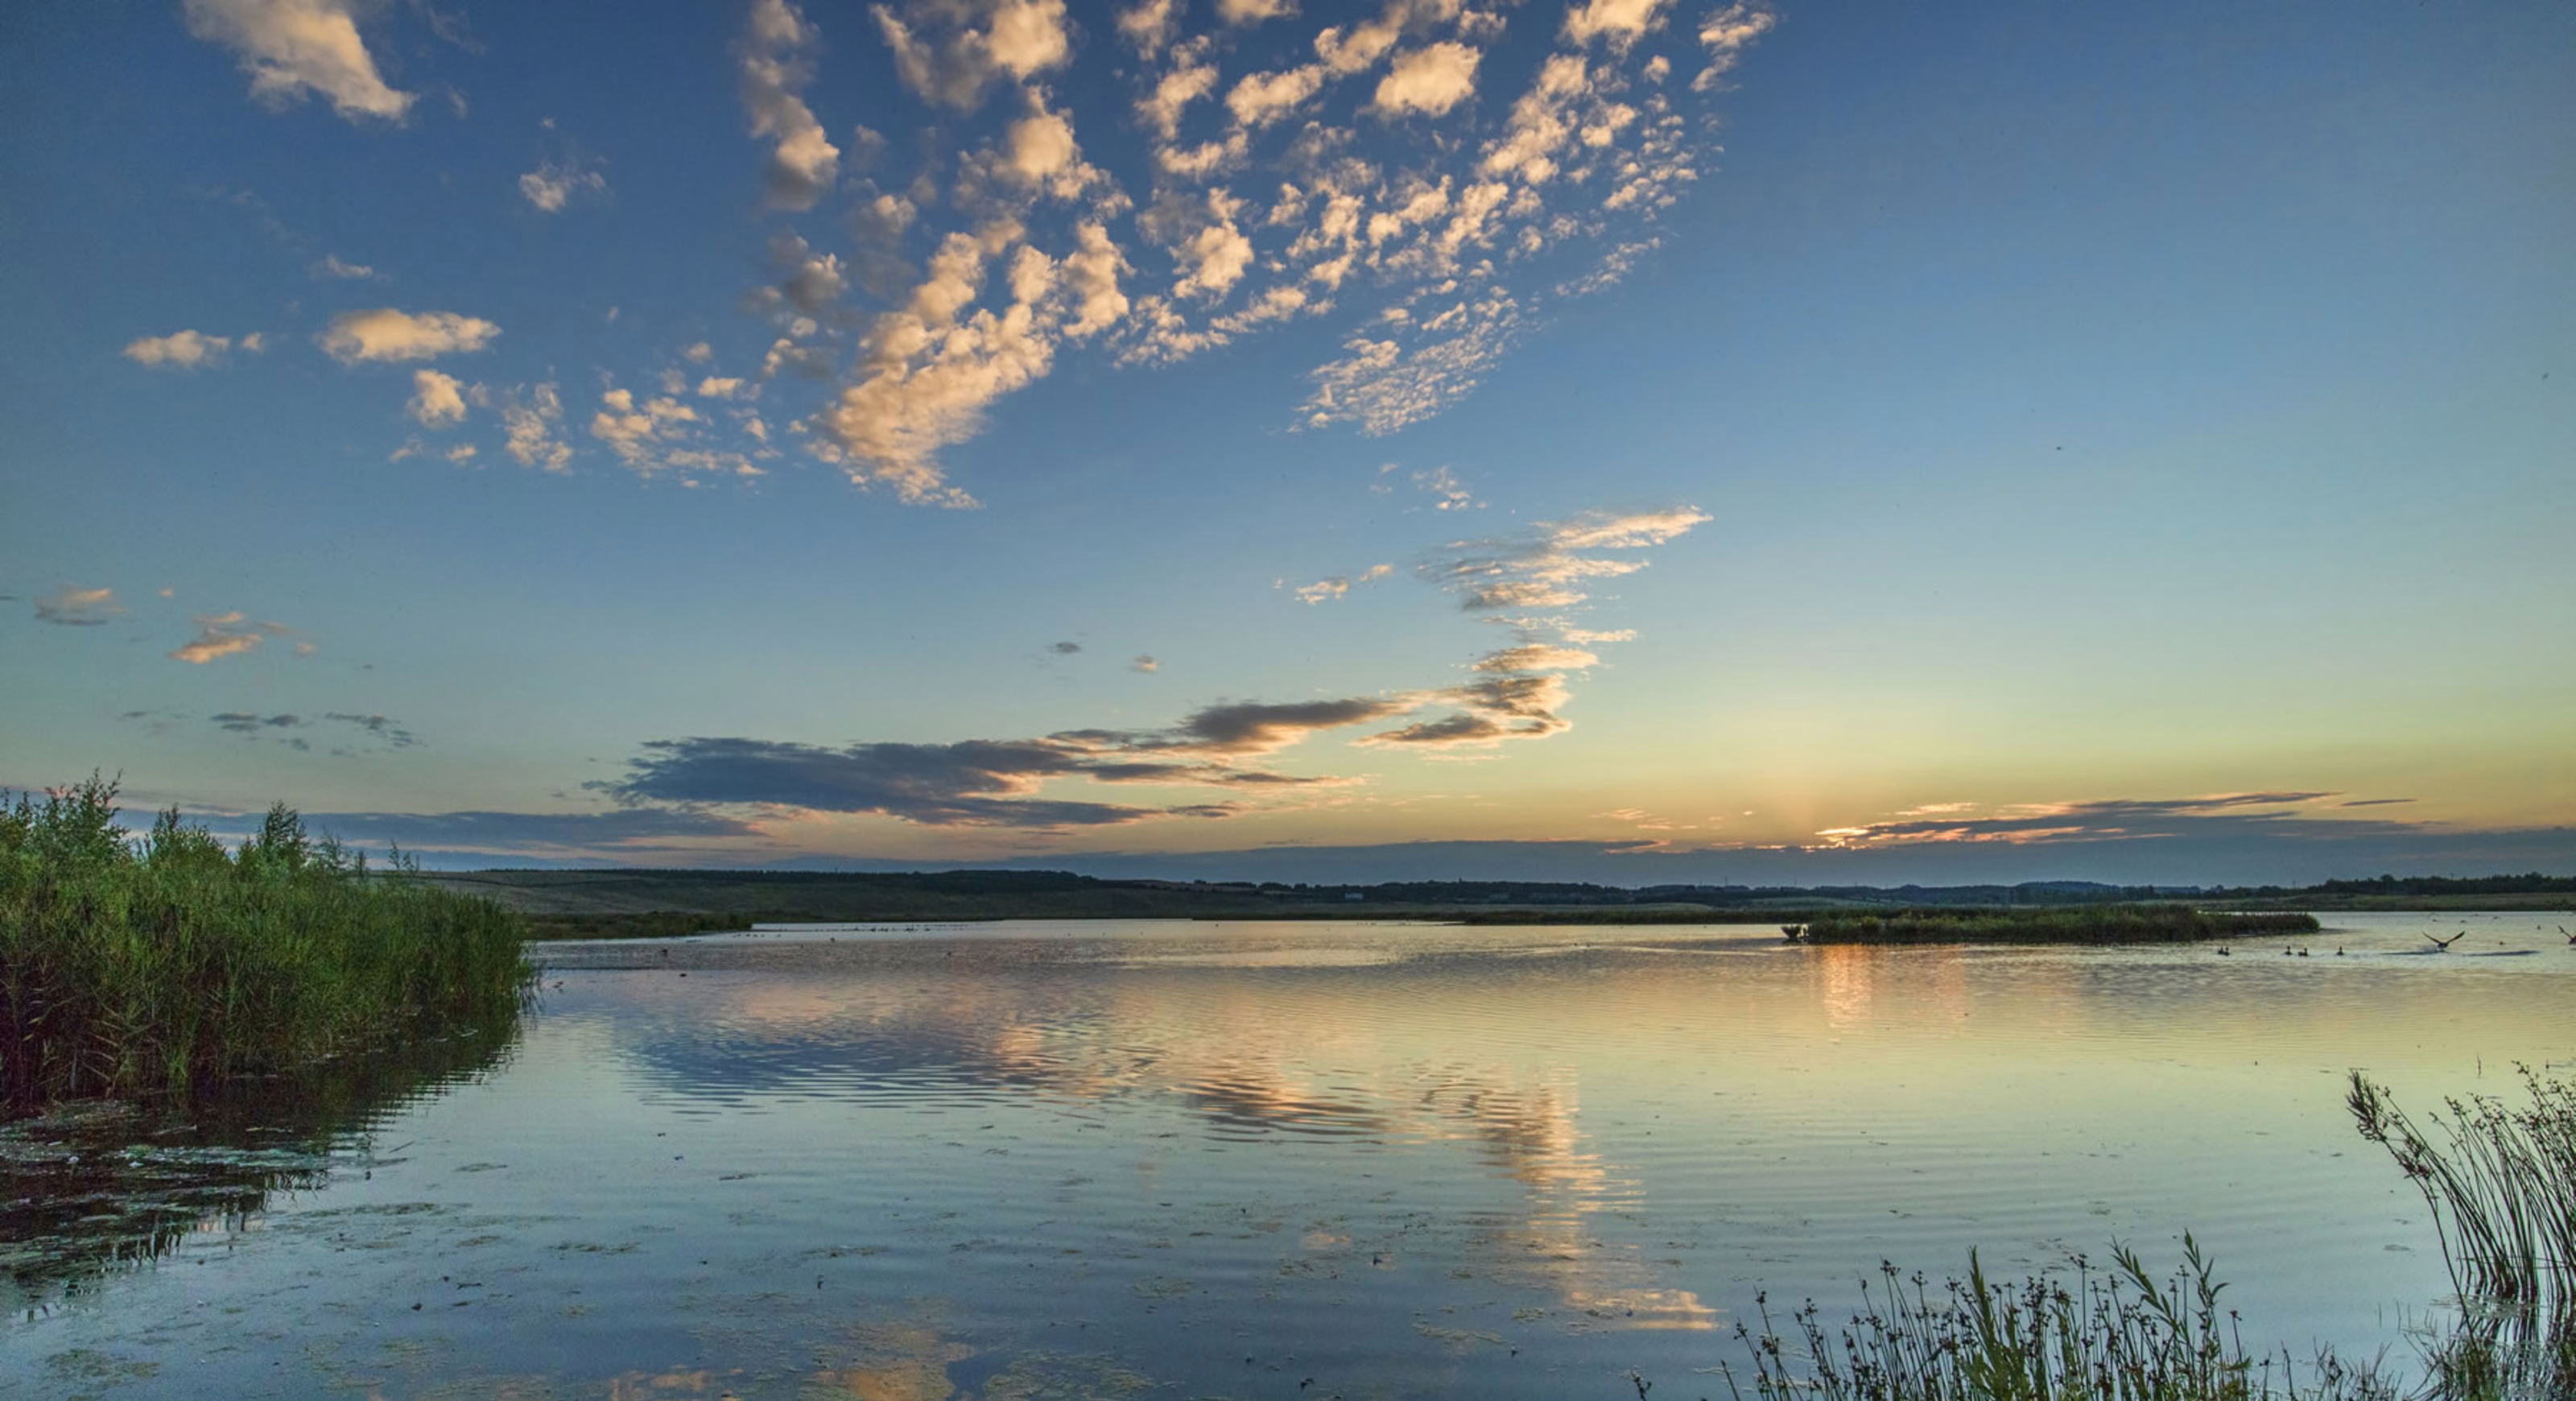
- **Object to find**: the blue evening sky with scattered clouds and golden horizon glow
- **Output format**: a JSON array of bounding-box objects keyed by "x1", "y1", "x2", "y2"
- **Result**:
[{"x1": 0, "y1": 0, "x2": 2576, "y2": 886}]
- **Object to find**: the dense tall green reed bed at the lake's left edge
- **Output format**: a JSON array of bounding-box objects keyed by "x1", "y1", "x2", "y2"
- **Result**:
[{"x1": 0, "y1": 778, "x2": 530, "y2": 1115}]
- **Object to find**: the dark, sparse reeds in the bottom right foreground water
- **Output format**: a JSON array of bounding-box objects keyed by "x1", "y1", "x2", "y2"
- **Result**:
[{"x1": 1710, "y1": 1068, "x2": 2576, "y2": 1401}]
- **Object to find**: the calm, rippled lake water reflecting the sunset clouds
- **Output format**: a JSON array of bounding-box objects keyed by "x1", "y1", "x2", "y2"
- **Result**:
[{"x1": 0, "y1": 914, "x2": 2576, "y2": 1401}]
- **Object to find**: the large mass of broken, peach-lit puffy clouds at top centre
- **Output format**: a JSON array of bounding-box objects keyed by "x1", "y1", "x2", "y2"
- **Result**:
[{"x1": 752, "y1": 0, "x2": 1752, "y2": 497}]
